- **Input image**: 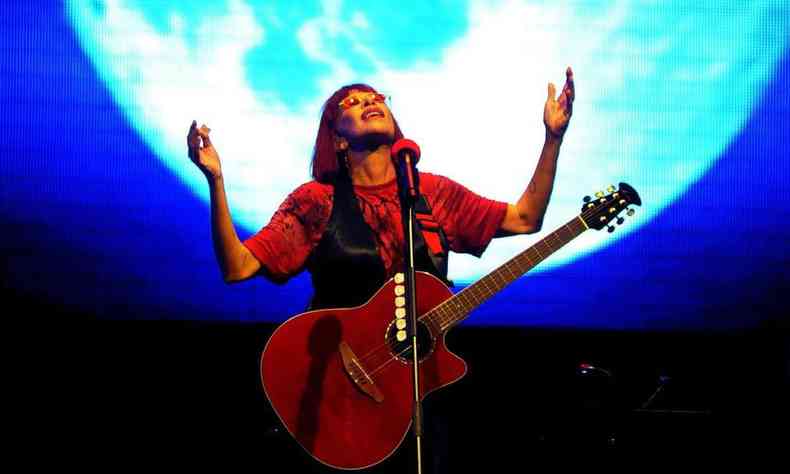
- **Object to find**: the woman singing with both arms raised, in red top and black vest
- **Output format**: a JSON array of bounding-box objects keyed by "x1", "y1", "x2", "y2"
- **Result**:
[{"x1": 187, "y1": 68, "x2": 574, "y2": 470}]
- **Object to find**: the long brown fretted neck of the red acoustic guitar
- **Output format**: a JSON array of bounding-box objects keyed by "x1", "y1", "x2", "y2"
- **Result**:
[{"x1": 420, "y1": 216, "x2": 587, "y2": 333}]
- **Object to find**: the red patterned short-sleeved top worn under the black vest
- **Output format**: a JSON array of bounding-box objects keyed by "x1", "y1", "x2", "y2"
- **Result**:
[{"x1": 243, "y1": 173, "x2": 507, "y2": 283}]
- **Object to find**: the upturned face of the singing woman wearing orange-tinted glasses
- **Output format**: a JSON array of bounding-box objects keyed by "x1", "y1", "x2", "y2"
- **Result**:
[{"x1": 336, "y1": 89, "x2": 395, "y2": 148}]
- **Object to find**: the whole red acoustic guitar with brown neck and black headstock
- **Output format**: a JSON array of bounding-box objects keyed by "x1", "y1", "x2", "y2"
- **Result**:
[{"x1": 261, "y1": 183, "x2": 641, "y2": 469}]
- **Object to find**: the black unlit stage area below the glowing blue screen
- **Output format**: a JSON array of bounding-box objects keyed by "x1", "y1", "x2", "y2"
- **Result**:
[{"x1": 20, "y1": 303, "x2": 790, "y2": 472}]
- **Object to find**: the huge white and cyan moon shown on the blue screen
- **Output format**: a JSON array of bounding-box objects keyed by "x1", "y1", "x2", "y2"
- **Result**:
[{"x1": 66, "y1": 0, "x2": 788, "y2": 282}]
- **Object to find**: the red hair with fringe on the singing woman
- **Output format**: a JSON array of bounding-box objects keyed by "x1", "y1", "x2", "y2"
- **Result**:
[{"x1": 310, "y1": 84, "x2": 403, "y2": 183}]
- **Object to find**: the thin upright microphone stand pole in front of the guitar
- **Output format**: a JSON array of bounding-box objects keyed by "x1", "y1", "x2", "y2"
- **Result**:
[{"x1": 397, "y1": 154, "x2": 423, "y2": 474}]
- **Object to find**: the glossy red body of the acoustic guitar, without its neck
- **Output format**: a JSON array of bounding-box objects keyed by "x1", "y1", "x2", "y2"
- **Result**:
[{"x1": 261, "y1": 272, "x2": 466, "y2": 469}]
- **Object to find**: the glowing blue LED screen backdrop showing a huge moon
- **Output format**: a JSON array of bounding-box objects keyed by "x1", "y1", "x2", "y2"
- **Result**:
[{"x1": 0, "y1": 0, "x2": 790, "y2": 329}]
